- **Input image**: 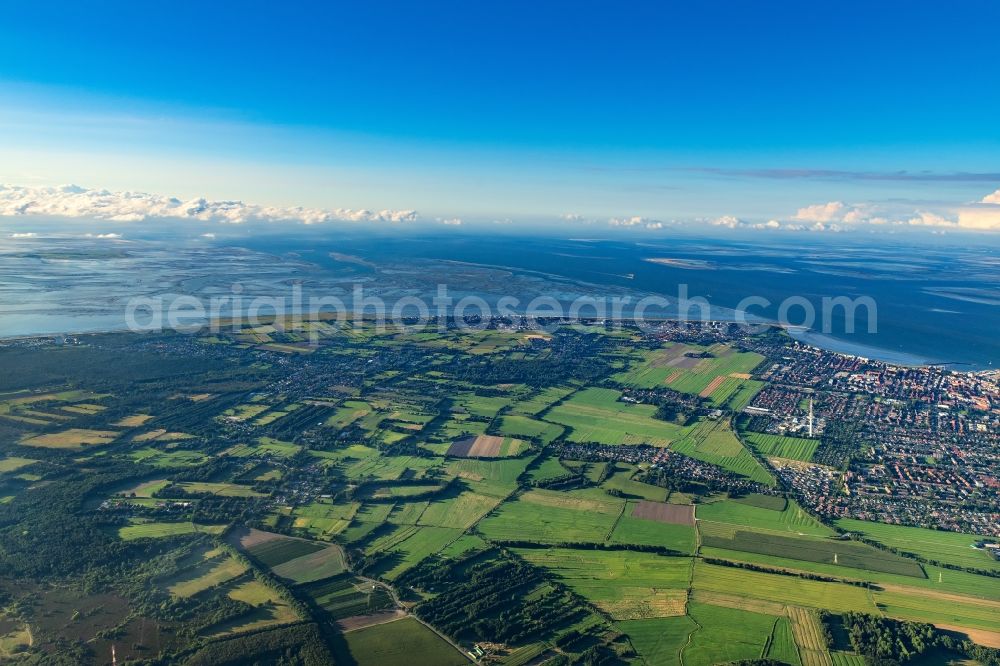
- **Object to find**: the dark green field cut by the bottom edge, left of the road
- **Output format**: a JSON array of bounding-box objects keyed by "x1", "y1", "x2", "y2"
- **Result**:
[{"x1": 340, "y1": 617, "x2": 469, "y2": 666}]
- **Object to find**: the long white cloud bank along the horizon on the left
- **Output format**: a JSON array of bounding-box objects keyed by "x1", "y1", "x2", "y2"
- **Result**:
[{"x1": 0, "y1": 185, "x2": 417, "y2": 224}]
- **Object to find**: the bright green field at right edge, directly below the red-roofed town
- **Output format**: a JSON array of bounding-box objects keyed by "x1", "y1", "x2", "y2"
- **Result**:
[{"x1": 837, "y1": 518, "x2": 1000, "y2": 571}]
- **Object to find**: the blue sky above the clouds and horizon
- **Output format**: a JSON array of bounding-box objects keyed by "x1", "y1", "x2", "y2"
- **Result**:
[{"x1": 0, "y1": 0, "x2": 1000, "y2": 227}]
